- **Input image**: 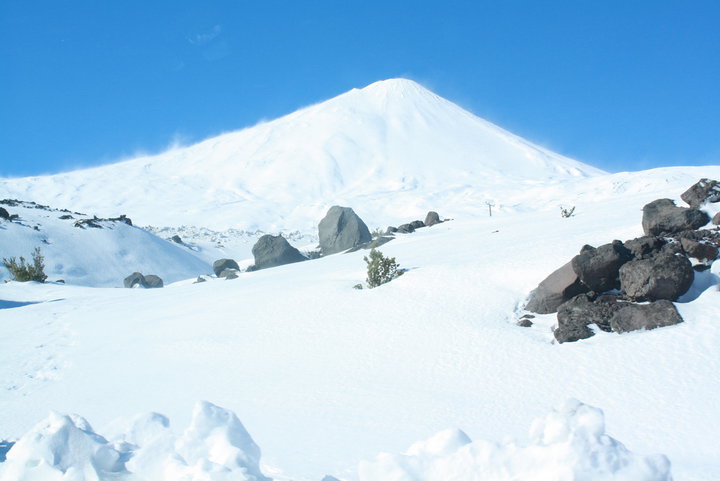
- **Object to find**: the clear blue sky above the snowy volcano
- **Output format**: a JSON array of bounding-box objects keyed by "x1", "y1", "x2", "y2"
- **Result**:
[{"x1": 0, "y1": 0, "x2": 720, "y2": 176}]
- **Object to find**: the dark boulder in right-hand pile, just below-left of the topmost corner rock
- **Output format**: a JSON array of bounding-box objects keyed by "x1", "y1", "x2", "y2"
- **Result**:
[{"x1": 642, "y1": 199, "x2": 710, "y2": 235}]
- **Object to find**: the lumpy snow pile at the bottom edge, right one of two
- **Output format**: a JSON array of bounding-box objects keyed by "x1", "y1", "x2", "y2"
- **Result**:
[{"x1": 359, "y1": 400, "x2": 672, "y2": 481}]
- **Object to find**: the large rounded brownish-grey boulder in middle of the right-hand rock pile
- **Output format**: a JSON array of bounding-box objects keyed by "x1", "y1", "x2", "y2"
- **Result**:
[{"x1": 620, "y1": 253, "x2": 695, "y2": 301}]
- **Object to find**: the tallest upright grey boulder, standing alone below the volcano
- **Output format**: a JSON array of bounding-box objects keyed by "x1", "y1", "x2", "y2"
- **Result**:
[{"x1": 318, "y1": 205, "x2": 372, "y2": 255}]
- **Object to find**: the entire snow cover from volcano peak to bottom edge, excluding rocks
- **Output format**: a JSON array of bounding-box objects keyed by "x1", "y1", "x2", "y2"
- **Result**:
[{"x1": 0, "y1": 80, "x2": 720, "y2": 481}]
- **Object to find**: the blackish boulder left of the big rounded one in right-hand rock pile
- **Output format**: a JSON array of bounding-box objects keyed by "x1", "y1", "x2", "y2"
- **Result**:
[{"x1": 571, "y1": 240, "x2": 632, "y2": 292}]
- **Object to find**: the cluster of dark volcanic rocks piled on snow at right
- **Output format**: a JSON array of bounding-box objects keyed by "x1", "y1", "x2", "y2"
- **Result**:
[{"x1": 519, "y1": 179, "x2": 720, "y2": 343}]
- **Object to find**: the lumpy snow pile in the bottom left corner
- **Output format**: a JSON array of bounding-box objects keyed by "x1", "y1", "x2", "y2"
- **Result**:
[{"x1": 0, "y1": 402, "x2": 270, "y2": 481}]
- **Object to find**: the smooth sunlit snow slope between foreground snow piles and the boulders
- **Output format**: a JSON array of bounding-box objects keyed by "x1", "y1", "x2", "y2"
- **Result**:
[{"x1": 0, "y1": 171, "x2": 720, "y2": 481}]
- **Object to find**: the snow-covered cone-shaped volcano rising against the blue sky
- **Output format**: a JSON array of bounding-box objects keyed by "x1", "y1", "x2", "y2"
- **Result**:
[{"x1": 0, "y1": 79, "x2": 603, "y2": 230}]
